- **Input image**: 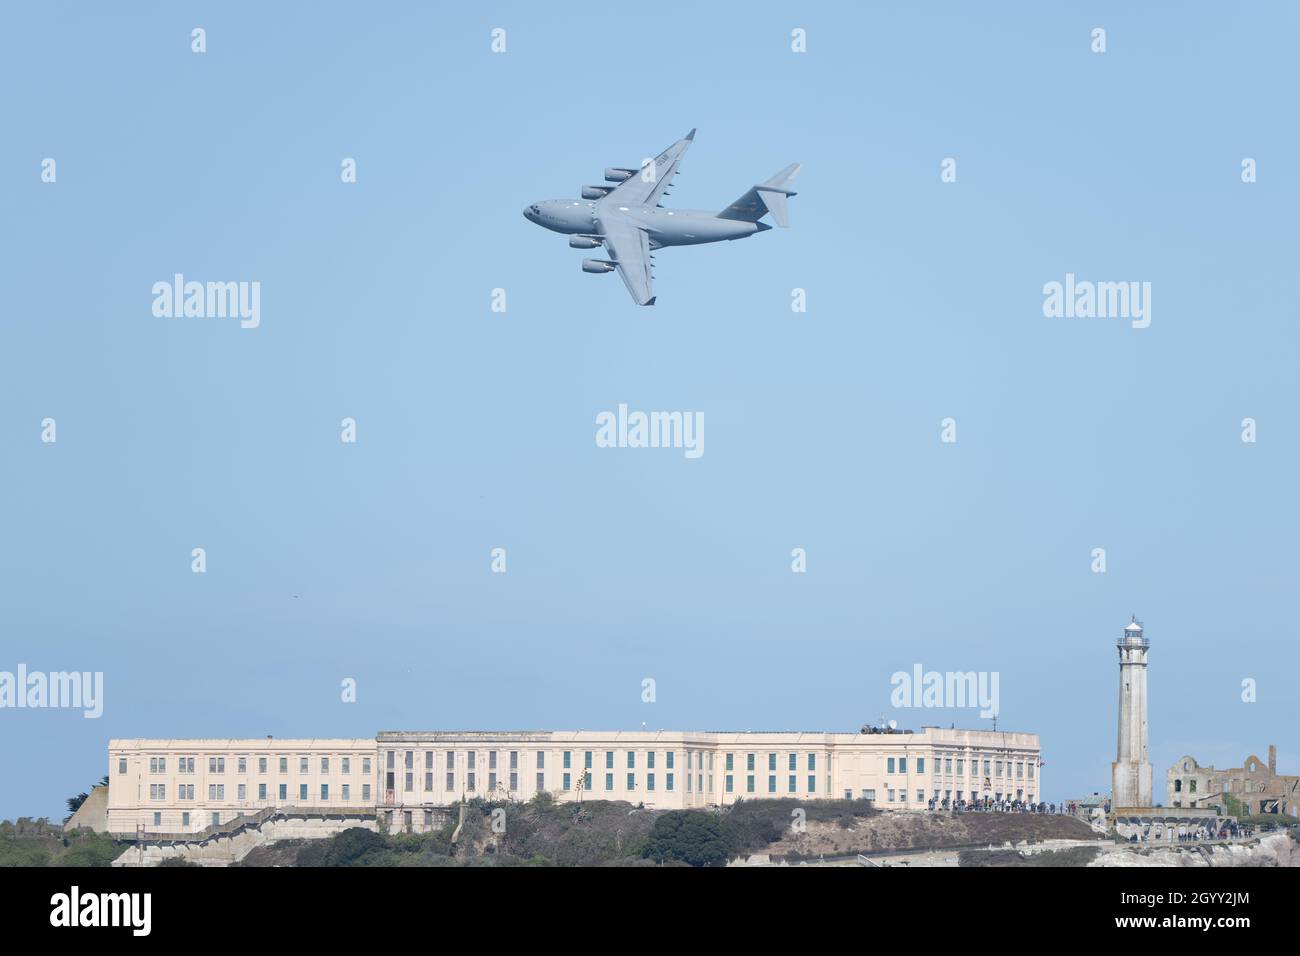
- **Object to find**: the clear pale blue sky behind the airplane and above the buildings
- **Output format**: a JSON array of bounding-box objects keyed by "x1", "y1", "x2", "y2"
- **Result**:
[{"x1": 0, "y1": 3, "x2": 1300, "y2": 818}]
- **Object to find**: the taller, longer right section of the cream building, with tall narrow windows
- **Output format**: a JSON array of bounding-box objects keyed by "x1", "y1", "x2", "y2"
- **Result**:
[{"x1": 377, "y1": 728, "x2": 1041, "y2": 831}]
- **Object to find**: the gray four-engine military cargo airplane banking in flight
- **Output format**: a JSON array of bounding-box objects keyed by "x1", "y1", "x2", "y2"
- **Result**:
[{"x1": 524, "y1": 130, "x2": 800, "y2": 306}]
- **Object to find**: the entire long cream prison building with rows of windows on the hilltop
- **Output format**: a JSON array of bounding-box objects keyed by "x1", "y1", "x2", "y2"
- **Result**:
[{"x1": 108, "y1": 727, "x2": 1041, "y2": 835}]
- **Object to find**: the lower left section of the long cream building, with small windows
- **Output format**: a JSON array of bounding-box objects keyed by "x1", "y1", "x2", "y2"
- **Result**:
[{"x1": 108, "y1": 737, "x2": 377, "y2": 832}]
